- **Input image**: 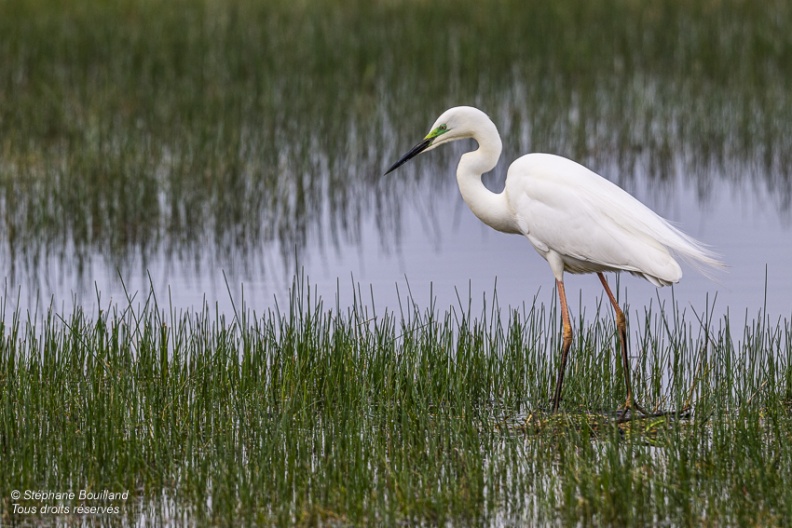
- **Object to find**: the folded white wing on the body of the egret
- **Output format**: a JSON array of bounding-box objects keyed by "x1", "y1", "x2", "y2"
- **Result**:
[{"x1": 506, "y1": 154, "x2": 682, "y2": 284}]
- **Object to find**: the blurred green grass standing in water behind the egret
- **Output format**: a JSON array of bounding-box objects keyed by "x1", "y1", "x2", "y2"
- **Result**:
[{"x1": 0, "y1": 0, "x2": 792, "y2": 277}]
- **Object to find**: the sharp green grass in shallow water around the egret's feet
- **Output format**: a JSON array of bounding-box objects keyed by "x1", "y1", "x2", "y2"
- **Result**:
[{"x1": 0, "y1": 278, "x2": 792, "y2": 526}]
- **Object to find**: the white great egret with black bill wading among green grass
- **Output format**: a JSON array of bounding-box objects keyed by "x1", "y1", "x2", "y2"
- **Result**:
[{"x1": 386, "y1": 106, "x2": 723, "y2": 414}]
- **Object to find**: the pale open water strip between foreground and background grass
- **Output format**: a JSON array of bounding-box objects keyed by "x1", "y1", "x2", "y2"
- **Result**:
[{"x1": 6, "y1": 144, "x2": 792, "y2": 322}]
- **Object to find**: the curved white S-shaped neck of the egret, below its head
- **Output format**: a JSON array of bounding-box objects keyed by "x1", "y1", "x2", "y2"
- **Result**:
[{"x1": 457, "y1": 131, "x2": 520, "y2": 233}]
